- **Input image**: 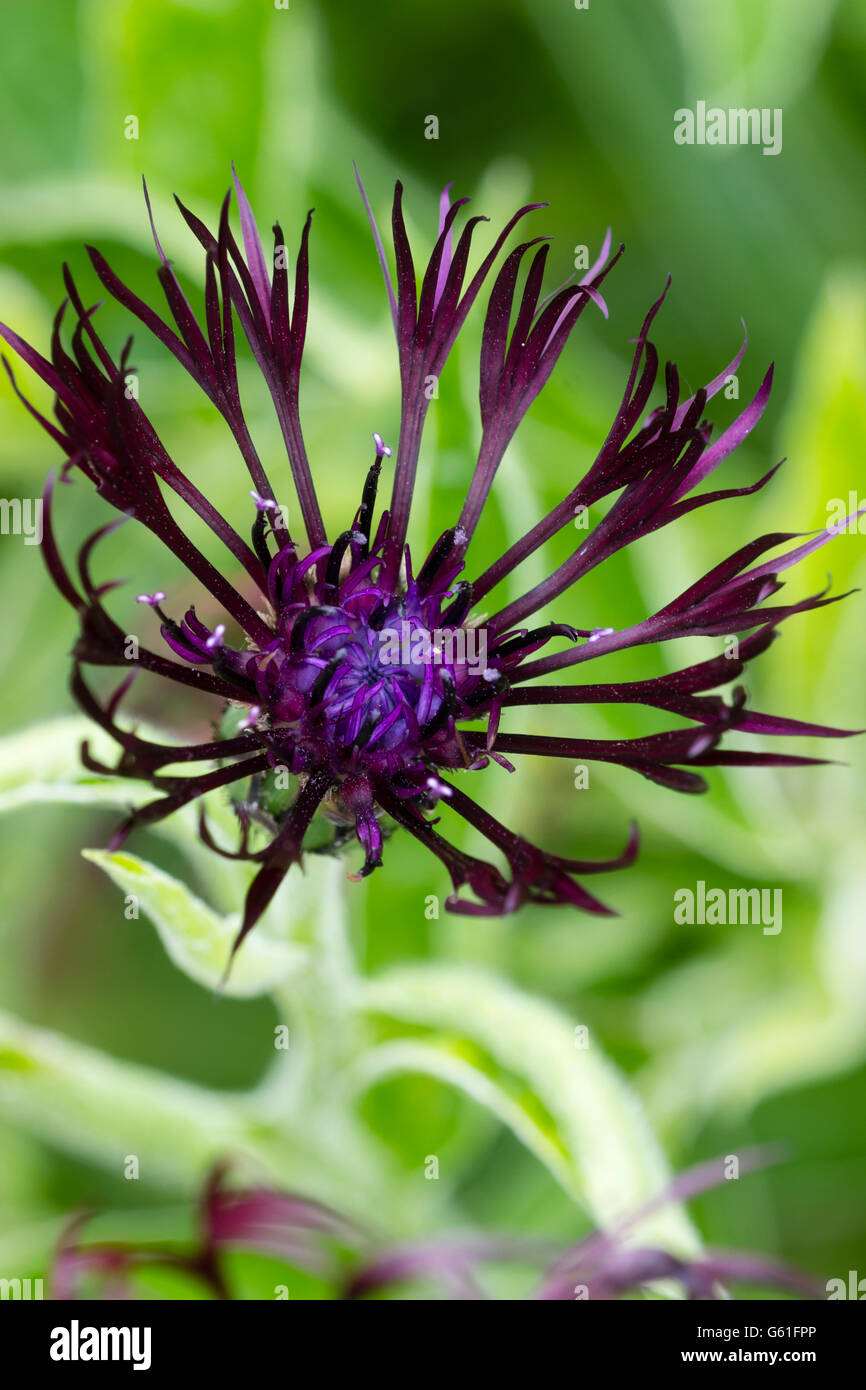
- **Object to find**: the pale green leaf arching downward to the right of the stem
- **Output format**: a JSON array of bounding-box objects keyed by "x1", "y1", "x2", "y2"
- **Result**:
[{"x1": 357, "y1": 965, "x2": 696, "y2": 1252}]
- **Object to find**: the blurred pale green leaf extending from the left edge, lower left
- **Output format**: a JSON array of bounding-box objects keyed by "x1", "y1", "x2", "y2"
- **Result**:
[{"x1": 0, "y1": 1011, "x2": 430, "y2": 1228}]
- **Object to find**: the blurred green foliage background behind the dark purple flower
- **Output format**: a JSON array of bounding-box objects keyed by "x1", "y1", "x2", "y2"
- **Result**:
[{"x1": 0, "y1": 0, "x2": 866, "y2": 1295}]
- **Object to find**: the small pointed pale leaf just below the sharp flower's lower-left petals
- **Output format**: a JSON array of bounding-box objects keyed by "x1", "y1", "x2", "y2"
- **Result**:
[{"x1": 82, "y1": 849, "x2": 310, "y2": 998}]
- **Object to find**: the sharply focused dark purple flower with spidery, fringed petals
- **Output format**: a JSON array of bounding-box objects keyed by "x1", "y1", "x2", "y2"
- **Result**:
[{"x1": 0, "y1": 168, "x2": 861, "y2": 949}]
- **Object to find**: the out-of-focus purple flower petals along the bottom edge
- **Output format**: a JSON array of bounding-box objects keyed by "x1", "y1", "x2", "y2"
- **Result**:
[{"x1": 51, "y1": 1159, "x2": 820, "y2": 1301}]
